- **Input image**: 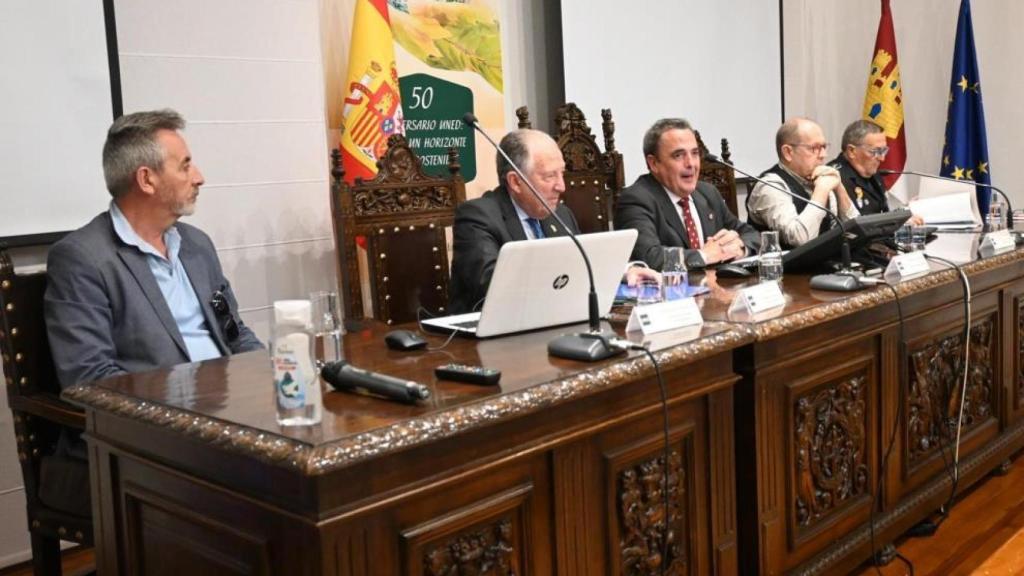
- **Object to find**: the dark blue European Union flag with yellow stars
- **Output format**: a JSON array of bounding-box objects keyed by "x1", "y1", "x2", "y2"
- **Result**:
[{"x1": 939, "y1": 0, "x2": 992, "y2": 217}]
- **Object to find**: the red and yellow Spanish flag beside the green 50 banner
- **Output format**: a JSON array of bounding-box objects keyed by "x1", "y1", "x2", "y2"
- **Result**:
[{"x1": 341, "y1": 0, "x2": 404, "y2": 182}]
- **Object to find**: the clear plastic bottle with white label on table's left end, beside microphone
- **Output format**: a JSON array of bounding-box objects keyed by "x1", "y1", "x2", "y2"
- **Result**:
[{"x1": 270, "y1": 300, "x2": 324, "y2": 426}]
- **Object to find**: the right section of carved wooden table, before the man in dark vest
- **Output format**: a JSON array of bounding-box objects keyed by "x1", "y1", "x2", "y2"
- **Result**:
[{"x1": 701, "y1": 234, "x2": 1024, "y2": 574}]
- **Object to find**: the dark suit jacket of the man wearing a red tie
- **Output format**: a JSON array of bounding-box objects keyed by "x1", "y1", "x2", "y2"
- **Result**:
[{"x1": 614, "y1": 174, "x2": 761, "y2": 270}]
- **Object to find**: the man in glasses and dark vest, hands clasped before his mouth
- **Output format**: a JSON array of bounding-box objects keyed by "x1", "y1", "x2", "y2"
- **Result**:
[{"x1": 746, "y1": 118, "x2": 860, "y2": 248}]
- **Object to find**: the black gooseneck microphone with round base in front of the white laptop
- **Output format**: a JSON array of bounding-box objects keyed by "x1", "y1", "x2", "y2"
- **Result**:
[{"x1": 462, "y1": 112, "x2": 625, "y2": 362}]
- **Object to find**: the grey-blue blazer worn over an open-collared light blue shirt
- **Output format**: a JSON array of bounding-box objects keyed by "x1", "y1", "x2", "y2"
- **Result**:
[{"x1": 45, "y1": 208, "x2": 262, "y2": 386}]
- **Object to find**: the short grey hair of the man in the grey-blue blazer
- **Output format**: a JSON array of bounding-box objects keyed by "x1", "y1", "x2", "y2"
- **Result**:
[{"x1": 103, "y1": 109, "x2": 185, "y2": 198}]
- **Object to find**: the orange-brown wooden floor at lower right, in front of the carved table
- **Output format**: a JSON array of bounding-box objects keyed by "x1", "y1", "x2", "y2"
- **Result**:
[{"x1": 854, "y1": 454, "x2": 1024, "y2": 576}]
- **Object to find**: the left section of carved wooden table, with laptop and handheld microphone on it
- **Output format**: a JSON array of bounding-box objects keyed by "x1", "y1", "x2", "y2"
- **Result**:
[{"x1": 66, "y1": 323, "x2": 753, "y2": 575}]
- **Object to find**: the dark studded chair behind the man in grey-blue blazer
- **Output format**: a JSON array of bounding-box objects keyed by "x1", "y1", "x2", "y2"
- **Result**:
[{"x1": 0, "y1": 247, "x2": 92, "y2": 575}]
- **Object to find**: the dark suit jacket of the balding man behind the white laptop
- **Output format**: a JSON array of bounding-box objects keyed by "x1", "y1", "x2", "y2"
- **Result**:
[{"x1": 449, "y1": 186, "x2": 580, "y2": 314}]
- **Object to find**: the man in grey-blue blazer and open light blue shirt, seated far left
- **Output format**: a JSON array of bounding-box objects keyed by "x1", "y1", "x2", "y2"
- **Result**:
[{"x1": 45, "y1": 110, "x2": 262, "y2": 386}]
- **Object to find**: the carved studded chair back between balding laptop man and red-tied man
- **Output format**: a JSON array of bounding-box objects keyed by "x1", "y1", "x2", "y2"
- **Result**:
[{"x1": 515, "y1": 102, "x2": 626, "y2": 233}]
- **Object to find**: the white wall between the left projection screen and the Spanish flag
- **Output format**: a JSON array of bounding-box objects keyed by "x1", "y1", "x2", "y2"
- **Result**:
[{"x1": 115, "y1": 0, "x2": 336, "y2": 340}]
